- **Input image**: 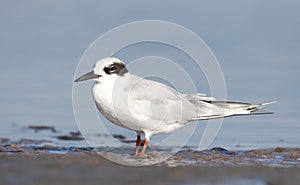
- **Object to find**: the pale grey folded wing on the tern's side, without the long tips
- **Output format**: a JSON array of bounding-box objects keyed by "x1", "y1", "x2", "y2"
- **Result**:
[{"x1": 128, "y1": 78, "x2": 193, "y2": 123}]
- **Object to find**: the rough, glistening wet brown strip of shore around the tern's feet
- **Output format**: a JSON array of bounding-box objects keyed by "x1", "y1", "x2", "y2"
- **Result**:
[{"x1": 0, "y1": 138, "x2": 300, "y2": 167}]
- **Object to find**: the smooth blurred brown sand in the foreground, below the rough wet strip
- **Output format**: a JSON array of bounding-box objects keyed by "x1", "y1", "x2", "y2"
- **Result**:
[{"x1": 0, "y1": 153, "x2": 300, "y2": 185}]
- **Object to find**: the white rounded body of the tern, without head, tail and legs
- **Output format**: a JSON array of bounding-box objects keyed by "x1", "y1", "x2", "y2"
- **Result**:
[{"x1": 93, "y1": 75, "x2": 197, "y2": 134}]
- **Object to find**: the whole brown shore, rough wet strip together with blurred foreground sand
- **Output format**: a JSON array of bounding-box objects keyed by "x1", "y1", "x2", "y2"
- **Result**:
[{"x1": 0, "y1": 138, "x2": 300, "y2": 185}]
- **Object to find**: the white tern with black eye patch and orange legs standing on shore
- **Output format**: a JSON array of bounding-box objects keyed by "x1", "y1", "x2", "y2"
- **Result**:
[{"x1": 74, "y1": 57, "x2": 275, "y2": 156}]
